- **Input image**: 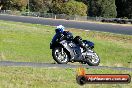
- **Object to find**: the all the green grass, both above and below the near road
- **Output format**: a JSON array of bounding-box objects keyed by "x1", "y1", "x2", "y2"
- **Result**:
[{"x1": 0, "y1": 21, "x2": 132, "y2": 88}]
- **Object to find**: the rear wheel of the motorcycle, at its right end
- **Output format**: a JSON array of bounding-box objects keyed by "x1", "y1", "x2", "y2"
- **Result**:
[{"x1": 87, "y1": 52, "x2": 100, "y2": 66}]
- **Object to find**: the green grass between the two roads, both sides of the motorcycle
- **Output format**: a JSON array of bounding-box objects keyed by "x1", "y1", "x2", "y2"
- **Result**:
[{"x1": 0, "y1": 21, "x2": 132, "y2": 67}]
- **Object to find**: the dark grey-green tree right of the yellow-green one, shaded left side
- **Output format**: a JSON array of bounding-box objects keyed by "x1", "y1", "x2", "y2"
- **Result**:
[{"x1": 89, "y1": 0, "x2": 117, "y2": 17}]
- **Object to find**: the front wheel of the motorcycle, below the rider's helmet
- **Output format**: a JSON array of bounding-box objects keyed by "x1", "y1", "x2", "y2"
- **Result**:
[{"x1": 52, "y1": 47, "x2": 69, "y2": 64}]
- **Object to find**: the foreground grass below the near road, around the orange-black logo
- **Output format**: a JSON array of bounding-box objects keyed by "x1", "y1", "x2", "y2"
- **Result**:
[{"x1": 0, "y1": 67, "x2": 132, "y2": 88}]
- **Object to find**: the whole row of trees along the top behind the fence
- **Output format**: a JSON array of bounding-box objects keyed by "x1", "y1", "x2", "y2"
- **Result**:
[{"x1": 0, "y1": 0, "x2": 132, "y2": 18}]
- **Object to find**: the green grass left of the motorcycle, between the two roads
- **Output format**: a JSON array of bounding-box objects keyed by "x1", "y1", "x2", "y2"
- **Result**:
[{"x1": 0, "y1": 22, "x2": 53, "y2": 62}]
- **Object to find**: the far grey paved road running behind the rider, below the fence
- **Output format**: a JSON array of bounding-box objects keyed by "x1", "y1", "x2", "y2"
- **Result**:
[{"x1": 0, "y1": 15, "x2": 132, "y2": 35}]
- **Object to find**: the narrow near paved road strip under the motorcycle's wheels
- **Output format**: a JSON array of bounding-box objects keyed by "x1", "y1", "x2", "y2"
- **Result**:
[{"x1": 0, "y1": 61, "x2": 132, "y2": 72}]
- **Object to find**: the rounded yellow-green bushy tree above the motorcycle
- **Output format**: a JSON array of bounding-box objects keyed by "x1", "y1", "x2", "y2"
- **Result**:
[{"x1": 52, "y1": 0, "x2": 87, "y2": 16}]
